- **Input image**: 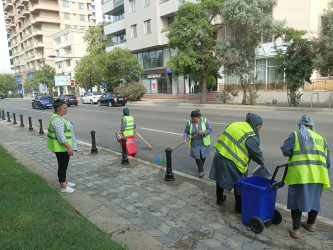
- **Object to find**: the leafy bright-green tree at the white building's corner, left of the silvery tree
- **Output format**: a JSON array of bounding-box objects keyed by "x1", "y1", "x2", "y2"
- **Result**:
[{"x1": 167, "y1": 0, "x2": 225, "y2": 103}]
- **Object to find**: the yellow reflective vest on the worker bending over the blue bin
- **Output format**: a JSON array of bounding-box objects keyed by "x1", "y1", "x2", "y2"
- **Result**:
[{"x1": 214, "y1": 122, "x2": 256, "y2": 173}]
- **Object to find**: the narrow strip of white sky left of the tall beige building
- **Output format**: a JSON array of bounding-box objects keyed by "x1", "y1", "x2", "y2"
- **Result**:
[{"x1": 0, "y1": 4, "x2": 14, "y2": 74}]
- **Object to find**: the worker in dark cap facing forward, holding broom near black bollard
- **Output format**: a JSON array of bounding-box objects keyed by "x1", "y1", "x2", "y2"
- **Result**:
[{"x1": 183, "y1": 109, "x2": 212, "y2": 178}]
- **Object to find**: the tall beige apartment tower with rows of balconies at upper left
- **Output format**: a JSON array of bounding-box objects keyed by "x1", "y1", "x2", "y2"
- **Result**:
[{"x1": 3, "y1": 0, "x2": 92, "y2": 92}]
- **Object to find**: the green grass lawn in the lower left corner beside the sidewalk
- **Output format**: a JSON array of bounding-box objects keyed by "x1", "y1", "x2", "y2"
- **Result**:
[{"x1": 0, "y1": 146, "x2": 128, "y2": 250}]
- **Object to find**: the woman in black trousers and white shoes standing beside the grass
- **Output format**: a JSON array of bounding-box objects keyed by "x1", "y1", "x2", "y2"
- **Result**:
[{"x1": 47, "y1": 101, "x2": 77, "y2": 193}]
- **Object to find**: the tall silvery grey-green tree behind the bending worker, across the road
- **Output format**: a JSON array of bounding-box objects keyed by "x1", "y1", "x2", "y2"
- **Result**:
[{"x1": 215, "y1": 0, "x2": 283, "y2": 104}]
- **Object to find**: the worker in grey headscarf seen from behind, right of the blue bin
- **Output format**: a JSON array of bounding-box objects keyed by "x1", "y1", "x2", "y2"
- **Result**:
[{"x1": 281, "y1": 115, "x2": 330, "y2": 239}]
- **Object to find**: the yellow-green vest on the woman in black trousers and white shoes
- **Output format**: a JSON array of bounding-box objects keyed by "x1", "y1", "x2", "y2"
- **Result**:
[{"x1": 46, "y1": 114, "x2": 73, "y2": 152}]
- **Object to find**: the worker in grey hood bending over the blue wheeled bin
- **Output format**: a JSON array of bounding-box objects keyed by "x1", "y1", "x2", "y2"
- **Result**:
[{"x1": 209, "y1": 113, "x2": 265, "y2": 213}]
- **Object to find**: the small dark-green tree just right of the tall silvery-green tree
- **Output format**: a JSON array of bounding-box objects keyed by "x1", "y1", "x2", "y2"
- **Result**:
[{"x1": 275, "y1": 28, "x2": 315, "y2": 106}]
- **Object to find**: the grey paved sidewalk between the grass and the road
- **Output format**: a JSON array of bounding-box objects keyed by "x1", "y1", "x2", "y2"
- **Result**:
[{"x1": 0, "y1": 120, "x2": 333, "y2": 250}]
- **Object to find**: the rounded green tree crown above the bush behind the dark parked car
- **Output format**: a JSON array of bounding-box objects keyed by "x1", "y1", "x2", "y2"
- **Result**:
[{"x1": 105, "y1": 48, "x2": 143, "y2": 86}]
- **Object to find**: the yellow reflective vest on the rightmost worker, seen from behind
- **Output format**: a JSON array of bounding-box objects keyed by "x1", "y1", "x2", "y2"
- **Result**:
[{"x1": 284, "y1": 130, "x2": 330, "y2": 190}]
